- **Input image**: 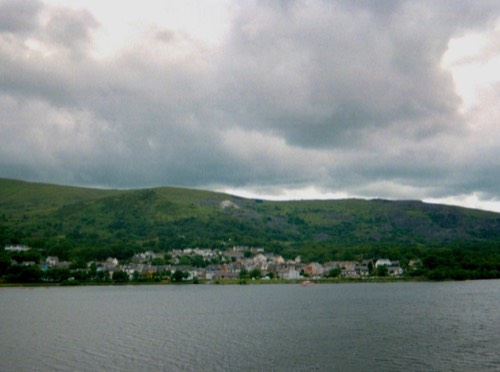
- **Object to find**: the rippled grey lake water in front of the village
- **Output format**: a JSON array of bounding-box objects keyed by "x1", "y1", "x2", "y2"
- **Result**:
[{"x1": 0, "y1": 280, "x2": 500, "y2": 371}]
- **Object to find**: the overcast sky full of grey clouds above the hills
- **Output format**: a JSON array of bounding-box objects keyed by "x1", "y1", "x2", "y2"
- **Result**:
[{"x1": 0, "y1": 0, "x2": 500, "y2": 211}]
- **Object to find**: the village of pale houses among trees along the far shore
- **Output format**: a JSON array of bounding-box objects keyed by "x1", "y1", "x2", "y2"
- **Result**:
[{"x1": 5, "y1": 246, "x2": 410, "y2": 282}]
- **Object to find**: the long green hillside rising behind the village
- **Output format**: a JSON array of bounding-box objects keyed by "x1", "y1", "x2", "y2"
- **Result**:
[{"x1": 0, "y1": 179, "x2": 500, "y2": 261}]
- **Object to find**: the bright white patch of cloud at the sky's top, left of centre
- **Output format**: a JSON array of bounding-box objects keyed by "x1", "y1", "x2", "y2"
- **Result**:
[{"x1": 44, "y1": 0, "x2": 231, "y2": 58}]
